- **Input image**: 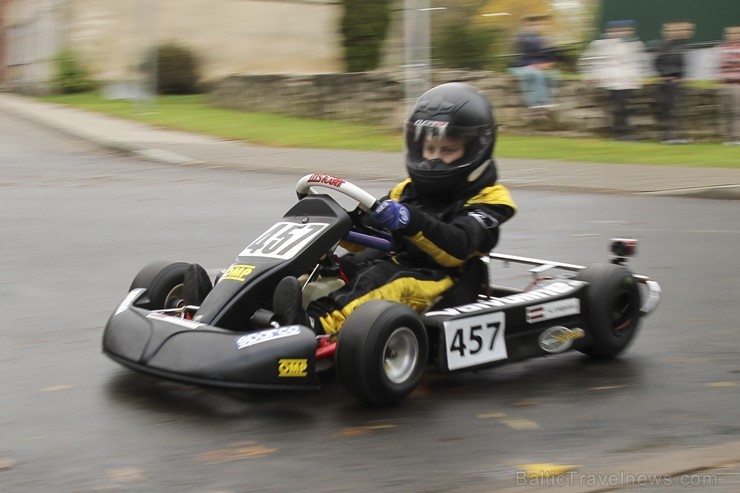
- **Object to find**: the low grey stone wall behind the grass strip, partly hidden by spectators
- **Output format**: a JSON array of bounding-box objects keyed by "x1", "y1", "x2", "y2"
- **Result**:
[{"x1": 210, "y1": 71, "x2": 720, "y2": 140}]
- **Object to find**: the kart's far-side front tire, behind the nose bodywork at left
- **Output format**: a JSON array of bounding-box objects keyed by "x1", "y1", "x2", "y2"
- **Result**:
[{"x1": 129, "y1": 261, "x2": 190, "y2": 310}]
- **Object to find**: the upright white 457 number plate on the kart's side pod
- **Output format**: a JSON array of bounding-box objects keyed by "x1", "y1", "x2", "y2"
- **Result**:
[{"x1": 444, "y1": 312, "x2": 508, "y2": 370}]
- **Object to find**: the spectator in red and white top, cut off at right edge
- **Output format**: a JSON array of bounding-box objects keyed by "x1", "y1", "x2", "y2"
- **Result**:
[{"x1": 717, "y1": 26, "x2": 740, "y2": 145}]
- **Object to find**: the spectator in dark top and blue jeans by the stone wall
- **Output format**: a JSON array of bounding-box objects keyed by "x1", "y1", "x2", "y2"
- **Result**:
[{"x1": 509, "y1": 15, "x2": 559, "y2": 116}]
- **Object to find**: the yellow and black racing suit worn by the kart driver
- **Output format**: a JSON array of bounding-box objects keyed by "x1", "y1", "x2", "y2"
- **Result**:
[{"x1": 306, "y1": 179, "x2": 516, "y2": 334}]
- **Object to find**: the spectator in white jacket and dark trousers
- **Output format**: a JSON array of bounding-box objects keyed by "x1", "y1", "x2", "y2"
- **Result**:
[{"x1": 579, "y1": 20, "x2": 646, "y2": 140}]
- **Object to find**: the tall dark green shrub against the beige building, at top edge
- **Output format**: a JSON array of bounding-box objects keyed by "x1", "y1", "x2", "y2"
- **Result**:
[{"x1": 341, "y1": 0, "x2": 391, "y2": 72}]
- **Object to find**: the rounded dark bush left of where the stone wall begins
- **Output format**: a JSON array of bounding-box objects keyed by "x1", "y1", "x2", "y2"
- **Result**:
[{"x1": 141, "y1": 43, "x2": 200, "y2": 94}]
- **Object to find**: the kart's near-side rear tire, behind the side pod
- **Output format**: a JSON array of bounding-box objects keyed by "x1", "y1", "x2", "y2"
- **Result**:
[{"x1": 577, "y1": 264, "x2": 641, "y2": 358}]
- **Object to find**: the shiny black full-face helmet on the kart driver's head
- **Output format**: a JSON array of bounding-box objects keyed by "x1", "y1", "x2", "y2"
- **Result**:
[{"x1": 405, "y1": 82, "x2": 497, "y2": 199}]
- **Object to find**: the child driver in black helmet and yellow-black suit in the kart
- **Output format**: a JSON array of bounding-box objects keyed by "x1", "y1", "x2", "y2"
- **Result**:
[{"x1": 273, "y1": 83, "x2": 516, "y2": 334}]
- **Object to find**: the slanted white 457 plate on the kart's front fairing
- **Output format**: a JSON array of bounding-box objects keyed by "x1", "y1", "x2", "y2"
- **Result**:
[{"x1": 239, "y1": 222, "x2": 329, "y2": 260}]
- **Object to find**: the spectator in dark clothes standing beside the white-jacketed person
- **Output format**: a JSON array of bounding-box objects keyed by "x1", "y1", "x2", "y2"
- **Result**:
[{"x1": 655, "y1": 22, "x2": 693, "y2": 144}]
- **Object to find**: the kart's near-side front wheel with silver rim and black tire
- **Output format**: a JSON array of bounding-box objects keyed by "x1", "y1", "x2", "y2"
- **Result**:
[{"x1": 336, "y1": 300, "x2": 429, "y2": 406}]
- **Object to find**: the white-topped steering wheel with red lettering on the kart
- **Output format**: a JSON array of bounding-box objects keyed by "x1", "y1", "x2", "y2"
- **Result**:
[{"x1": 295, "y1": 173, "x2": 396, "y2": 251}]
